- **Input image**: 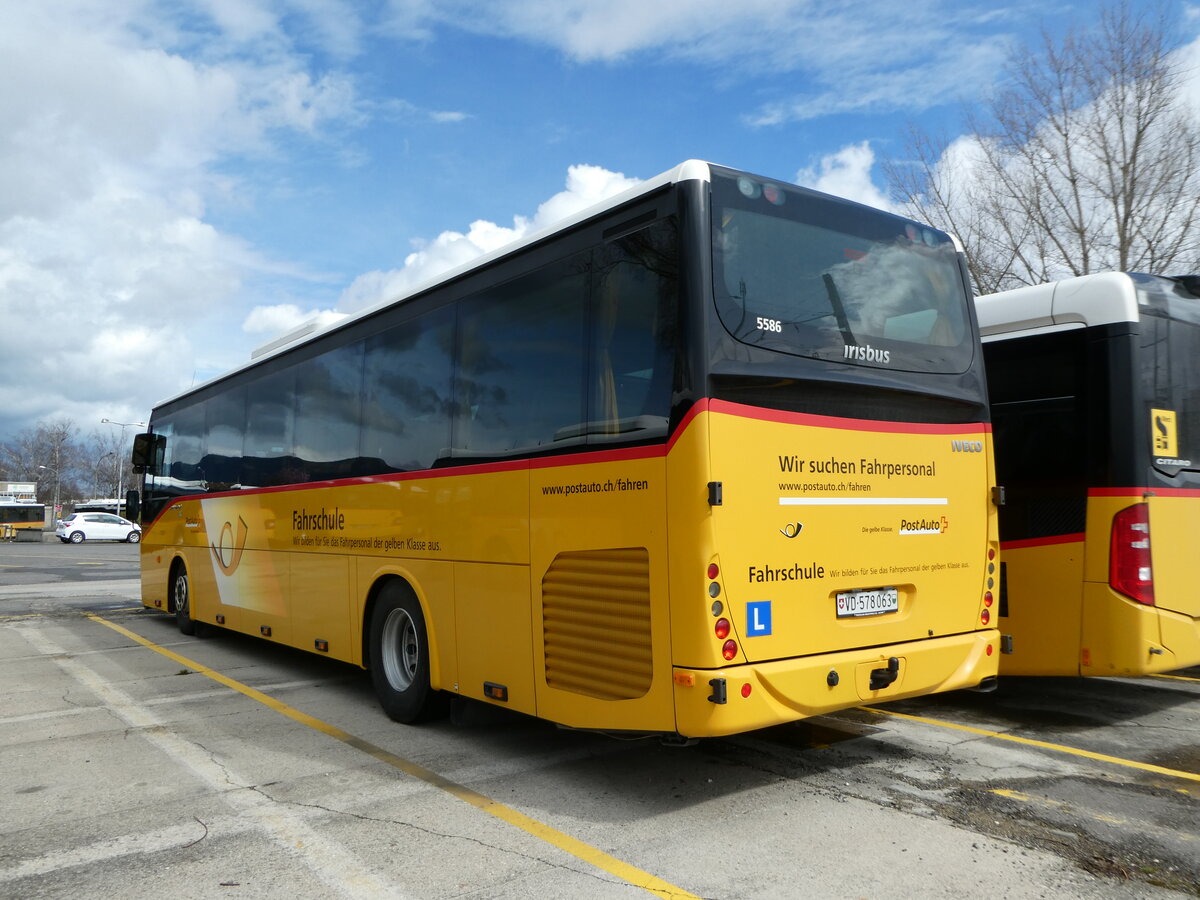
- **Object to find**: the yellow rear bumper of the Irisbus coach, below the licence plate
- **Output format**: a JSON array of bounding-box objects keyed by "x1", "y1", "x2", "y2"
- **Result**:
[{"x1": 674, "y1": 629, "x2": 1000, "y2": 738}]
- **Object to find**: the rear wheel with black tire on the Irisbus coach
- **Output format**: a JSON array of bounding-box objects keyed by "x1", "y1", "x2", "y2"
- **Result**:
[{"x1": 370, "y1": 581, "x2": 449, "y2": 725}]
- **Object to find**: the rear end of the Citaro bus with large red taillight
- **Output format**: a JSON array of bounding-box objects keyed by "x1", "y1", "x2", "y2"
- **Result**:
[{"x1": 1080, "y1": 274, "x2": 1200, "y2": 674}]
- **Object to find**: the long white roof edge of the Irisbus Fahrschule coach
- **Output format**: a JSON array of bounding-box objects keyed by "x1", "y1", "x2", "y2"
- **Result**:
[{"x1": 155, "y1": 160, "x2": 724, "y2": 408}]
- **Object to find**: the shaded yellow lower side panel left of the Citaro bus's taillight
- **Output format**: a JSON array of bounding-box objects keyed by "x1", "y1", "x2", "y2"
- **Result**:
[{"x1": 1000, "y1": 539, "x2": 1084, "y2": 676}]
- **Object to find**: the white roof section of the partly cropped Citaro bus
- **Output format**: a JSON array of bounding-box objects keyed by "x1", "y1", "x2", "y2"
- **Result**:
[{"x1": 976, "y1": 272, "x2": 1138, "y2": 341}]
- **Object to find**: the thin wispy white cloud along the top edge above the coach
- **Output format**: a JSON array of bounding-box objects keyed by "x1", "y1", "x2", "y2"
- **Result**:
[{"x1": 390, "y1": 0, "x2": 1017, "y2": 126}]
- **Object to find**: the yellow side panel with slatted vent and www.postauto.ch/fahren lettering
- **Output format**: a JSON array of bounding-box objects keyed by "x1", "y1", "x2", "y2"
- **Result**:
[{"x1": 529, "y1": 458, "x2": 676, "y2": 731}]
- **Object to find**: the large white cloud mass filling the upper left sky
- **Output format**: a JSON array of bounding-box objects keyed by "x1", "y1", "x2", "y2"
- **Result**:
[{"x1": 0, "y1": 0, "x2": 361, "y2": 439}]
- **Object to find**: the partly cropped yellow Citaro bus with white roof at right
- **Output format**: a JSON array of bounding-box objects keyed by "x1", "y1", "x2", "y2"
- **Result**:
[{"x1": 977, "y1": 272, "x2": 1200, "y2": 676}]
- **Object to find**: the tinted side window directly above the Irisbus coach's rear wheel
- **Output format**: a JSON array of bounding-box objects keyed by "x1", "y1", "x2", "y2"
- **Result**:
[{"x1": 362, "y1": 306, "x2": 454, "y2": 472}]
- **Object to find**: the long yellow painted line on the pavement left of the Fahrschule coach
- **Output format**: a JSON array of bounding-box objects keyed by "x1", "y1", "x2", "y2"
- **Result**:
[{"x1": 86, "y1": 613, "x2": 700, "y2": 900}]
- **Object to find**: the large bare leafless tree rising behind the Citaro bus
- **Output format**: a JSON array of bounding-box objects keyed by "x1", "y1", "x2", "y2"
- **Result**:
[{"x1": 884, "y1": 0, "x2": 1200, "y2": 293}]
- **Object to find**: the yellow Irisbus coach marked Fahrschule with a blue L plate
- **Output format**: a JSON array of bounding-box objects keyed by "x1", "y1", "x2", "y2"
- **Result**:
[{"x1": 134, "y1": 161, "x2": 998, "y2": 740}]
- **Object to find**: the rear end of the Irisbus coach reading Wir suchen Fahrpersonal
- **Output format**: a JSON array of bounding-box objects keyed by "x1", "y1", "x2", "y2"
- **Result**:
[{"x1": 668, "y1": 172, "x2": 1000, "y2": 736}]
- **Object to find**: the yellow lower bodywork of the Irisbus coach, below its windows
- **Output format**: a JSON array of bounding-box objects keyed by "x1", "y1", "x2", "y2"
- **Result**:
[{"x1": 142, "y1": 401, "x2": 1000, "y2": 737}]
